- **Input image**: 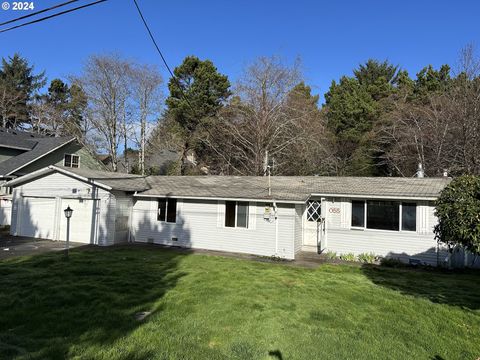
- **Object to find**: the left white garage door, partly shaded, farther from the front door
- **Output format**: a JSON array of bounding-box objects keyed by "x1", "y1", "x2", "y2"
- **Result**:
[{"x1": 17, "y1": 196, "x2": 55, "y2": 239}]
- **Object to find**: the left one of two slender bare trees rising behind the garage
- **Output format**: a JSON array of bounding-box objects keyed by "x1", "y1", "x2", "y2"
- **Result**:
[{"x1": 77, "y1": 55, "x2": 131, "y2": 171}]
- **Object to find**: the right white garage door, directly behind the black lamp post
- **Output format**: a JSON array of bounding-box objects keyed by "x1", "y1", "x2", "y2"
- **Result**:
[{"x1": 58, "y1": 199, "x2": 98, "y2": 244}]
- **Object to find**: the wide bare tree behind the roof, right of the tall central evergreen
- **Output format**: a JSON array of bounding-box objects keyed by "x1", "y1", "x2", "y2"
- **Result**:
[{"x1": 206, "y1": 57, "x2": 318, "y2": 175}]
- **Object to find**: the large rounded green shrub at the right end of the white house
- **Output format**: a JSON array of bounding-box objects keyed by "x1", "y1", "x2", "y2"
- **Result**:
[{"x1": 434, "y1": 175, "x2": 480, "y2": 255}]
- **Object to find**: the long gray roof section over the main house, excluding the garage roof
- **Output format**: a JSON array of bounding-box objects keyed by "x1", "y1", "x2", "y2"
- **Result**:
[{"x1": 139, "y1": 176, "x2": 450, "y2": 202}]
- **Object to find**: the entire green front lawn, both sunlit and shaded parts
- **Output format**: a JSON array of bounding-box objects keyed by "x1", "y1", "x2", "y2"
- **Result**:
[{"x1": 0, "y1": 247, "x2": 480, "y2": 360}]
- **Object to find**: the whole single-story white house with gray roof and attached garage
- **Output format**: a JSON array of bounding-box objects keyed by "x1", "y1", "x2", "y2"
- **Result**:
[{"x1": 8, "y1": 166, "x2": 464, "y2": 265}]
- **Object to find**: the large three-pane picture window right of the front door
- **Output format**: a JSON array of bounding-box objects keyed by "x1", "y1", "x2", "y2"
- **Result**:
[{"x1": 352, "y1": 200, "x2": 417, "y2": 231}]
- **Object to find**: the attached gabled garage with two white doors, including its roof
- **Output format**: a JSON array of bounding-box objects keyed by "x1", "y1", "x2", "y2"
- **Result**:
[{"x1": 9, "y1": 166, "x2": 146, "y2": 245}]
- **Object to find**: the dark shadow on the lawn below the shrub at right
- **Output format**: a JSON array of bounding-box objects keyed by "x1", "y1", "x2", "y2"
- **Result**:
[{"x1": 362, "y1": 264, "x2": 480, "y2": 310}]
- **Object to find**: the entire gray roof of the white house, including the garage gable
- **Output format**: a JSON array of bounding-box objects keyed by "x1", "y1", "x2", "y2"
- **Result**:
[{"x1": 6, "y1": 166, "x2": 451, "y2": 202}]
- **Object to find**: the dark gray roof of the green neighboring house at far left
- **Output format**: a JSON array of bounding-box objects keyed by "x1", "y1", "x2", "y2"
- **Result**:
[{"x1": 0, "y1": 129, "x2": 75, "y2": 176}]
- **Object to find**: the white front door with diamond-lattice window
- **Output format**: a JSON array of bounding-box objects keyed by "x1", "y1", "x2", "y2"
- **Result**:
[{"x1": 303, "y1": 200, "x2": 325, "y2": 252}]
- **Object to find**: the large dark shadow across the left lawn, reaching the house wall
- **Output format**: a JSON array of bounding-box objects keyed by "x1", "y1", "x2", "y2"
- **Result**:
[{"x1": 0, "y1": 211, "x2": 190, "y2": 359}]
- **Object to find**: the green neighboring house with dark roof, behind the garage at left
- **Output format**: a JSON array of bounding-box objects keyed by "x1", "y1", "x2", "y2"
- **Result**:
[{"x1": 0, "y1": 128, "x2": 106, "y2": 225}]
